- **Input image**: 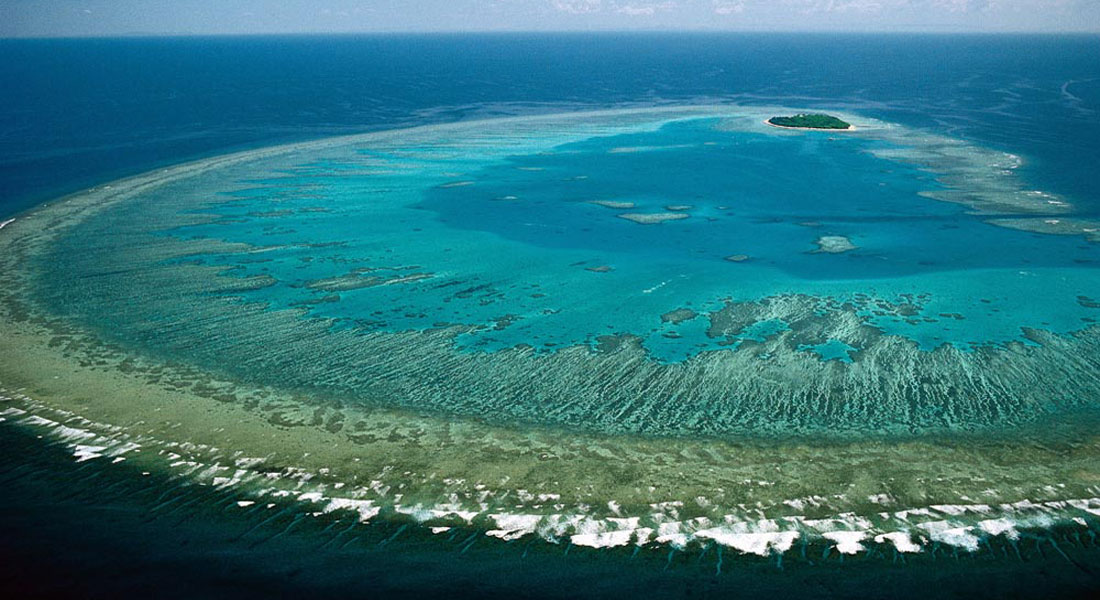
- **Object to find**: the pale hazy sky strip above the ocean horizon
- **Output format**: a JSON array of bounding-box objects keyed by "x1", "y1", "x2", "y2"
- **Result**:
[{"x1": 0, "y1": 0, "x2": 1100, "y2": 37}]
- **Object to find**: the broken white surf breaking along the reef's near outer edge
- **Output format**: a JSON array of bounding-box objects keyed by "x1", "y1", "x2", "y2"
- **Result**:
[{"x1": 19, "y1": 387, "x2": 1100, "y2": 556}]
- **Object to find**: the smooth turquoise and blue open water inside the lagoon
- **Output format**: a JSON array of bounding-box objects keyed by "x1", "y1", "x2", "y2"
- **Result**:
[{"x1": 160, "y1": 118, "x2": 1100, "y2": 361}]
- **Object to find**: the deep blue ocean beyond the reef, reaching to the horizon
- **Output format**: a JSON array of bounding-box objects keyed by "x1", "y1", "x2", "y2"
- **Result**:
[{"x1": 0, "y1": 33, "x2": 1100, "y2": 219}]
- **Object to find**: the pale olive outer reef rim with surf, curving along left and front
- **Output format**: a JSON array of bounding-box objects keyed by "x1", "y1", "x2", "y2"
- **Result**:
[{"x1": 0, "y1": 109, "x2": 1100, "y2": 554}]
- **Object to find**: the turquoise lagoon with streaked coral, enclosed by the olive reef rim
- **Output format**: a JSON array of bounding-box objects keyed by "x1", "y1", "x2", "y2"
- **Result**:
[{"x1": 23, "y1": 107, "x2": 1100, "y2": 437}]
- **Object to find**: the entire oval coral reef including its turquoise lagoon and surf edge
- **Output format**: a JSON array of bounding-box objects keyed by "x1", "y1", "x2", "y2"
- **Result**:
[{"x1": 0, "y1": 107, "x2": 1100, "y2": 572}]
